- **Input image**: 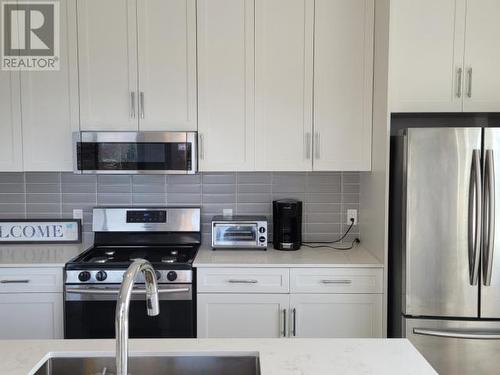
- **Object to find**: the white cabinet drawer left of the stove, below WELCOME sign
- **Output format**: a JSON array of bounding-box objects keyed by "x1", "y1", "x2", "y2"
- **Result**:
[{"x1": 0, "y1": 267, "x2": 63, "y2": 293}]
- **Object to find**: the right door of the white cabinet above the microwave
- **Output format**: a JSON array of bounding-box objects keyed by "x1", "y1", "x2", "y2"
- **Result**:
[{"x1": 137, "y1": 0, "x2": 199, "y2": 130}]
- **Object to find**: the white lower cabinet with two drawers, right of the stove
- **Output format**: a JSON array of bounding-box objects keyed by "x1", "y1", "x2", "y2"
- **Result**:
[{"x1": 197, "y1": 268, "x2": 383, "y2": 338}]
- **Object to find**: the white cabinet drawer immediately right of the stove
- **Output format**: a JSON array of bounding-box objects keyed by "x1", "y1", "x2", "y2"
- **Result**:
[{"x1": 198, "y1": 268, "x2": 290, "y2": 293}]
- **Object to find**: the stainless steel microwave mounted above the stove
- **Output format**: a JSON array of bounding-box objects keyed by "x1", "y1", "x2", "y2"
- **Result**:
[{"x1": 73, "y1": 131, "x2": 197, "y2": 174}]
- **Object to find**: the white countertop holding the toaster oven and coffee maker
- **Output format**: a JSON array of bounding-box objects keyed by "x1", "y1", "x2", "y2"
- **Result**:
[{"x1": 194, "y1": 245, "x2": 383, "y2": 268}]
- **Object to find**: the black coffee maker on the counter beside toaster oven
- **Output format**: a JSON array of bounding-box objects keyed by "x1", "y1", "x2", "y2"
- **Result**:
[{"x1": 273, "y1": 199, "x2": 302, "y2": 250}]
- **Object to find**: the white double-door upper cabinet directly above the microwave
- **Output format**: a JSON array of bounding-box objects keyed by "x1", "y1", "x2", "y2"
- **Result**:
[{"x1": 78, "y1": 0, "x2": 197, "y2": 130}]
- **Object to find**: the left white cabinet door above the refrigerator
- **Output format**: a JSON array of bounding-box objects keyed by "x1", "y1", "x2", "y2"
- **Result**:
[{"x1": 390, "y1": 0, "x2": 464, "y2": 112}]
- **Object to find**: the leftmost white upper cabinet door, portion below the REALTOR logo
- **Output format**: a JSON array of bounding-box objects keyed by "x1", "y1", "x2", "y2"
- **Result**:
[{"x1": 0, "y1": 70, "x2": 23, "y2": 172}]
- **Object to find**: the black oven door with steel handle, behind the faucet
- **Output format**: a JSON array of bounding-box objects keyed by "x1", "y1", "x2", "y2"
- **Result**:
[{"x1": 64, "y1": 284, "x2": 195, "y2": 339}]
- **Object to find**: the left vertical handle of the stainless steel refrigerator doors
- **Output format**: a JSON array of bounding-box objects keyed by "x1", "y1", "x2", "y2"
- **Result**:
[{"x1": 468, "y1": 150, "x2": 482, "y2": 285}]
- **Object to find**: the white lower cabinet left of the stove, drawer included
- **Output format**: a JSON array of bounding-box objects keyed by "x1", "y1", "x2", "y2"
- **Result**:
[{"x1": 0, "y1": 267, "x2": 64, "y2": 340}]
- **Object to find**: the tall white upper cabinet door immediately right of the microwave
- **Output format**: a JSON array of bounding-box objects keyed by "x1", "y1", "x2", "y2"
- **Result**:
[{"x1": 198, "y1": 0, "x2": 255, "y2": 171}]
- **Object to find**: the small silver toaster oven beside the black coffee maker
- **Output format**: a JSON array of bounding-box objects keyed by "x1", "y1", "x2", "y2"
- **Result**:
[{"x1": 212, "y1": 216, "x2": 267, "y2": 250}]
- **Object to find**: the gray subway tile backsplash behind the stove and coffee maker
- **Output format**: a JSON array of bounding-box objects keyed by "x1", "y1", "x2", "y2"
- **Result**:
[{"x1": 0, "y1": 172, "x2": 360, "y2": 241}]
